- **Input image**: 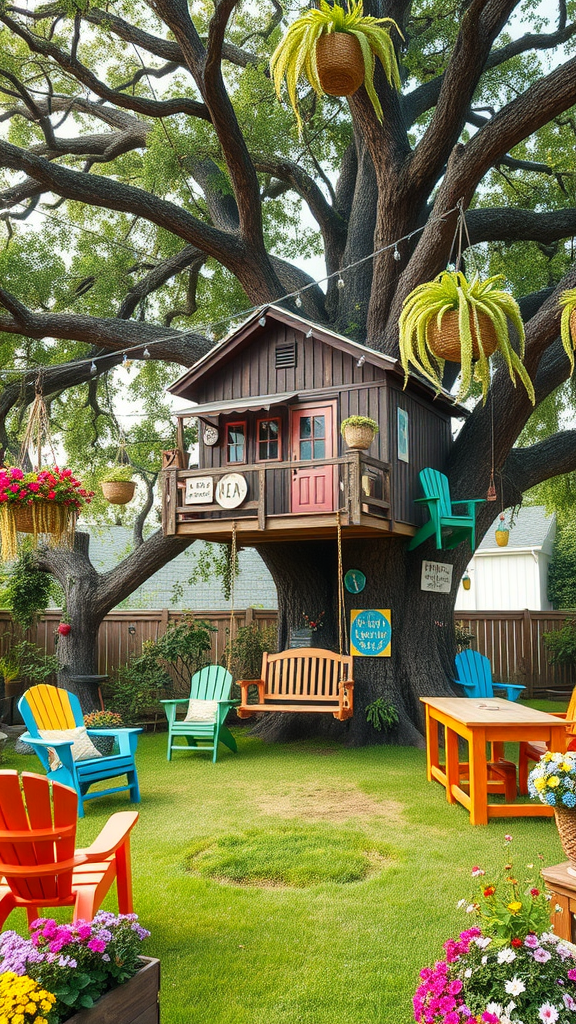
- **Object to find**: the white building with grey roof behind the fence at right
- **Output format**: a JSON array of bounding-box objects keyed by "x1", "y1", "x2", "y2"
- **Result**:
[{"x1": 456, "y1": 505, "x2": 556, "y2": 611}]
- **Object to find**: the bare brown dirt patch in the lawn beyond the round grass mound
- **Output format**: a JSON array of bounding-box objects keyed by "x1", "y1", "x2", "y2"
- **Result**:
[{"x1": 256, "y1": 781, "x2": 403, "y2": 823}]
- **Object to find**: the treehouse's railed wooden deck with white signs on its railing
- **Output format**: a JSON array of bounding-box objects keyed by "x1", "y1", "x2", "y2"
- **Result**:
[{"x1": 162, "y1": 451, "x2": 407, "y2": 545}]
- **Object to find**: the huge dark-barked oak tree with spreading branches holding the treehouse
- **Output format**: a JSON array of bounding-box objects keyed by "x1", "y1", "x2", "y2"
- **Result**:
[{"x1": 0, "y1": 0, "x2": 576, "y2": 742}]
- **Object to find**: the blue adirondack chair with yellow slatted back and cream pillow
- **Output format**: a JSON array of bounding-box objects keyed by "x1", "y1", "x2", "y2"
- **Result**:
[{"x1": 18, "y1": 683, "x2": 142, "y2": 818}]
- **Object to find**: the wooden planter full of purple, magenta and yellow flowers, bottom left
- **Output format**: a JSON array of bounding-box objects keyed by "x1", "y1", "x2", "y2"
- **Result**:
[{"x1": 0, "y1": 910, "x2": 160, "y2": 1024}]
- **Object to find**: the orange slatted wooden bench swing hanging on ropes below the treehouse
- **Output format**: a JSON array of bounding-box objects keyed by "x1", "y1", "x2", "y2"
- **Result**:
[{"x1": 236, "y1": 647, "x2": 354, "y2": 722}]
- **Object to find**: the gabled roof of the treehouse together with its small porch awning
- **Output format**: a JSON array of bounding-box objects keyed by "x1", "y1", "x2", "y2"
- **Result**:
[{"x1": 168, "y1": 305, "x2": 463, "y2": 417}]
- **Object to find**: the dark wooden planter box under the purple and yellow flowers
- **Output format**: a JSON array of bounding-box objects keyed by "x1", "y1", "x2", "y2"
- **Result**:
[{"x1": 66, "y1": 956, "x2": 160, "y2": 1024}]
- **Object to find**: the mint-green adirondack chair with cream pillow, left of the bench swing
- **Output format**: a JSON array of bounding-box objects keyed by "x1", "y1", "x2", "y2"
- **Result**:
[{"x1": 162, "y1": 665, "x2": 239, "y2": 764}]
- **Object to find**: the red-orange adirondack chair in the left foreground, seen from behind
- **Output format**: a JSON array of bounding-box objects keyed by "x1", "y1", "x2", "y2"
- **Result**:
[{"x1": 0, "y1": 770, "x2": 138, "y2": 928}]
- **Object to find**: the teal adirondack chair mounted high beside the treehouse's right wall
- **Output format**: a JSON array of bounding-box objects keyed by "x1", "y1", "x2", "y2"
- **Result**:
[{"x1": 408, "y1": 468, "x2": 486, "y2": 551}]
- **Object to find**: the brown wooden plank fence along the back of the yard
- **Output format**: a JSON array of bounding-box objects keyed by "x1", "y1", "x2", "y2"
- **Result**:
[{"x1": 0, "y1": 608, "x2": 576, "y2": 696}]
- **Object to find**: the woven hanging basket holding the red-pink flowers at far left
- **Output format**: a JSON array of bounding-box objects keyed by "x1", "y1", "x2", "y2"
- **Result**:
[{"x1": 0, "y1": 501, "x2": 76, "y2": 561}]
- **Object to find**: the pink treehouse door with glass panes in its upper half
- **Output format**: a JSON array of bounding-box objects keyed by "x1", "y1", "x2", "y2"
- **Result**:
[{"x1": 291, "y1": 406, "x2": 334, "y2": 512}]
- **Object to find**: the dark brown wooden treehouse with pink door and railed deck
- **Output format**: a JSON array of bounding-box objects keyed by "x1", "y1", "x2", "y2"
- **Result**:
[{"x1": 162, "y1": 306, "x2": 465, "y2": 545}]
